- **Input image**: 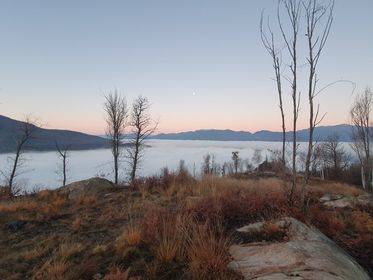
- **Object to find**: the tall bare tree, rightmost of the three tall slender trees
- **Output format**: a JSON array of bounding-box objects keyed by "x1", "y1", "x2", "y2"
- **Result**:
[{"x1": 302, "y1": 0, "x2": 334, "y2": 186}]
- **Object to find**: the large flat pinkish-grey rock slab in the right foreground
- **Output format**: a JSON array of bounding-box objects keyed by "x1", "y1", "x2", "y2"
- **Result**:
[{"x1": 229, "y1": 218, "x2": 370, "y2": 280}]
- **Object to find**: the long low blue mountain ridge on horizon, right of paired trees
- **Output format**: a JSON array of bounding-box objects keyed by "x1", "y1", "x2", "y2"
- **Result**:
[{"x1": 151, "y1": 124, "x2": 352, "y2": 142}]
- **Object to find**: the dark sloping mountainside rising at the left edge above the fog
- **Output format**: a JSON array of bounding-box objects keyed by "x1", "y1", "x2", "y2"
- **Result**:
[{"x1": 0, "y1": 115, "x2": 108, "y2": 153}]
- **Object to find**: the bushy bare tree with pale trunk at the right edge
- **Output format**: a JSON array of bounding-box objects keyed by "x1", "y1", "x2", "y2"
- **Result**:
[{"x1": 350, "y1": 88, "x2": 373, "y2": 191}]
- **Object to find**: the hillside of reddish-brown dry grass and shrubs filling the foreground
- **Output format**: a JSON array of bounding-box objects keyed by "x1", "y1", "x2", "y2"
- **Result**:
[{"x1": 0, "y1": 172, "x2": 373, "y2": 279}]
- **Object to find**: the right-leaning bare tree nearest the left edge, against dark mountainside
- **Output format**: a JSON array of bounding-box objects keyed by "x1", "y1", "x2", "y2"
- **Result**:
[{"x1": 7, "y1": 117, "x2": 37, "y2": 195}]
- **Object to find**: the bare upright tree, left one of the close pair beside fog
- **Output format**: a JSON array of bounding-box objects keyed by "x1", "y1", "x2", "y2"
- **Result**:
[{"x1": 104, "y1": 90, "x2": 128, "y2": 184}]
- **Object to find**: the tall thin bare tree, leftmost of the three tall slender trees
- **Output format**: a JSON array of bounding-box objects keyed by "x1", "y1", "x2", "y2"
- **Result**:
[{"x1": 260, "y1": 13, "x2": 286, "y2": 166}]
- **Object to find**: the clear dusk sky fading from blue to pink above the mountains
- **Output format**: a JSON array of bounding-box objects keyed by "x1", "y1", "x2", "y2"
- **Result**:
[{"x1": 0, "y1": 0, "x2": 373, "y2": 134}]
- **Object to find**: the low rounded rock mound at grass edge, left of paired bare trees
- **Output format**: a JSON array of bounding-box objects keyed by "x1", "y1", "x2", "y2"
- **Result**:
[{"x1": 59, "y1": 177, "x2": 115, "y2": 199}]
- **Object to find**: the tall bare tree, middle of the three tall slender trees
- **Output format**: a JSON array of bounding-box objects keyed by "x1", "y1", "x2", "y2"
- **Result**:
[{"x1": 277, "y1": 0, "x2": 301, "y2": 203}]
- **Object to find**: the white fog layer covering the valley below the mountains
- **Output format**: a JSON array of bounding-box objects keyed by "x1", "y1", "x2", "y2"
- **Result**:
[{"x1": 0, "y1": 140, "x2": 349, "y2": 190}]
